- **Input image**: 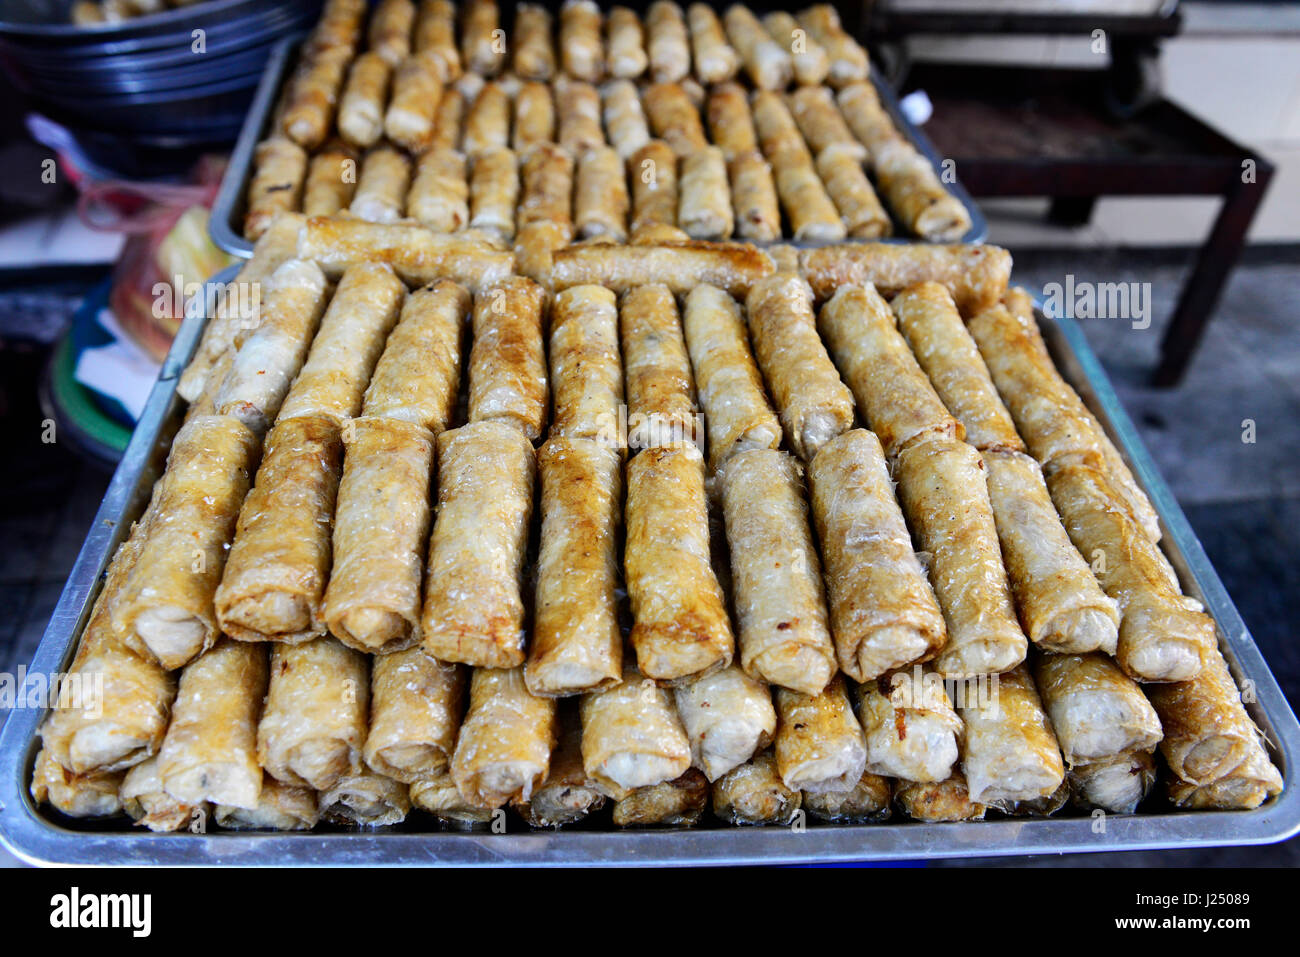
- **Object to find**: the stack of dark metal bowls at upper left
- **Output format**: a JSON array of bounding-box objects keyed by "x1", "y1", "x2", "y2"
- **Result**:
[{"x1": 0, "y1": 0, "x2": 321, "y2": 174}]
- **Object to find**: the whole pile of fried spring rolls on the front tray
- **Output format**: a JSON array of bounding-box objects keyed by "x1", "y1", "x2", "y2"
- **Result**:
[{"x1": 33, "y1": 204, "x2": 1282, "y2": 831}]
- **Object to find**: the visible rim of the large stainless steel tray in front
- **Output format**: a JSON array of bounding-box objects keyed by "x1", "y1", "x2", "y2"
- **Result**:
[{"x1": 0, "y1": 267, "x2": 1300, "y2": 866}]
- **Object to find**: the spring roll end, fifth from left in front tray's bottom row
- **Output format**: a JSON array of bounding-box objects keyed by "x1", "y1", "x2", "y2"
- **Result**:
[{"x1": 451, "y1": 668, "x2": 556, "y2": 807}]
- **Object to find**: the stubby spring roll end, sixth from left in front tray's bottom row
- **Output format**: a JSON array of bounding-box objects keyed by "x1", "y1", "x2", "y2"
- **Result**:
[{"x1": 580, "y1": 664, "x2": 690, "y2": 801}]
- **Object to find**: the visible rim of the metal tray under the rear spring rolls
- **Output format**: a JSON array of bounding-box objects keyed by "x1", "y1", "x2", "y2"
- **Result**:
[{"x1": 208, "y1": 35, "x2": 988, "y2": 257}]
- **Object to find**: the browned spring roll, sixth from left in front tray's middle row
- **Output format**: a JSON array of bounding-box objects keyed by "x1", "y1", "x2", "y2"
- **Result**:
[{"x1": 624, "y1": 443, "x2": 735, "y2": 681}]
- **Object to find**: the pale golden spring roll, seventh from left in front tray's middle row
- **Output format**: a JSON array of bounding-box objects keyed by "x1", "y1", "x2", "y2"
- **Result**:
[{"x1": 718, "y1": 449, "x2": 836, "y2": 694}]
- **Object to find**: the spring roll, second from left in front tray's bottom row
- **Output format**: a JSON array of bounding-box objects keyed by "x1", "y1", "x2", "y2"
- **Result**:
[{"x1": 159, "y1": 638, "x2": 267, "y2": 807}]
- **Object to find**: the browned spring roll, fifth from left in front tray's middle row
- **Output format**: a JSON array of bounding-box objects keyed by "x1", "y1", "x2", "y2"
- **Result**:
[{"x1": 524, "y1": 439, "x2": 623, "y2": 697}]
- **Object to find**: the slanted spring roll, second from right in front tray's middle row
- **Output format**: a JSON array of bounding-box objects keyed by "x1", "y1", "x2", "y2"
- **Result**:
[{"x1": 983, "y1": 451, "x2": 1122, "y2": 655}]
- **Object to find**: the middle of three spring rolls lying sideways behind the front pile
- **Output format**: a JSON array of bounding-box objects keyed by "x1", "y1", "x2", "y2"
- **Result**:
[{"x1": 551, "y1": 241, "x2": 774, "y2": 296}]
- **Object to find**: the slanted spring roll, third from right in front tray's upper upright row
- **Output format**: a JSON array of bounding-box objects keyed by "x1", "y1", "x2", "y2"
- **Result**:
[{"x1": 818, "y1": 285, "x2": 965, "y2": 459}]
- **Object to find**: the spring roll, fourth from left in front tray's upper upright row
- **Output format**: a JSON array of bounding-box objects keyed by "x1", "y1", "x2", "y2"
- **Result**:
[{"x1": 469, "y1": 277, "x2": 549, "y2": 441}]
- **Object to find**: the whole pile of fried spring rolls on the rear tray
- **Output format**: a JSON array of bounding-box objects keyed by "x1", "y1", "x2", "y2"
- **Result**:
[{"x1": 243, "y1": 0, "x2": 971, "y2": 250}]
